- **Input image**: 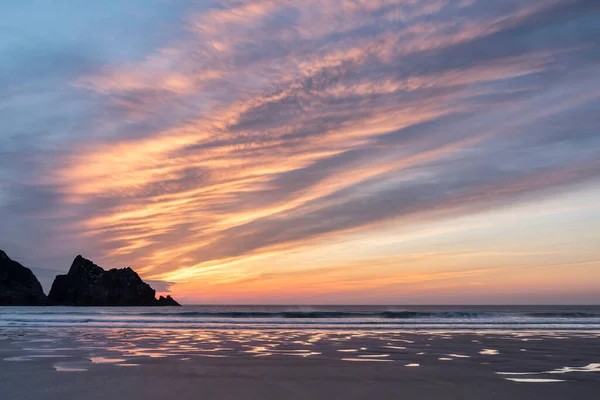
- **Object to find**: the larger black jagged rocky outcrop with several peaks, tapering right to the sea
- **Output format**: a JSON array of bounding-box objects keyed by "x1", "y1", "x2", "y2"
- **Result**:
[{"x1": 48, "y1": 256, "x2": 179, "y2": 306}]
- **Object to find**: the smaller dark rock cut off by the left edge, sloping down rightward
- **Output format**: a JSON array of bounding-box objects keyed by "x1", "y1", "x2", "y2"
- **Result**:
[{"x1": 0, "y1": 250, "x2": 46, "y2": 306}]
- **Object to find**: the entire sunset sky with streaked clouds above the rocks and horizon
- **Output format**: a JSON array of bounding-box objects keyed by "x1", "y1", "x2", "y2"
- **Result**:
[{"x1": 0, "y1": 0, "x2": 600, "y2": 304}]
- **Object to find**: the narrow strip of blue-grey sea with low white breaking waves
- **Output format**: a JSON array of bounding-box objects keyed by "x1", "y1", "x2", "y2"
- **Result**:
[{"x1": 0, "y1": 305, "x2": 600, "y2": 332}]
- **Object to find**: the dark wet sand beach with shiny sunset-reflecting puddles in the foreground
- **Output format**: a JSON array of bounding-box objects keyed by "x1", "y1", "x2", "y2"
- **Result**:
[{"x1": 0, "y1": 329, "x2": 600, "y2": 400}]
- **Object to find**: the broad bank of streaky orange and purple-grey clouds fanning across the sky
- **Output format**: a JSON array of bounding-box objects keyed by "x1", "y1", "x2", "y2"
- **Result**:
[{"x1": 0, "y1": 0, "x2": 600, "y2": 302}]
